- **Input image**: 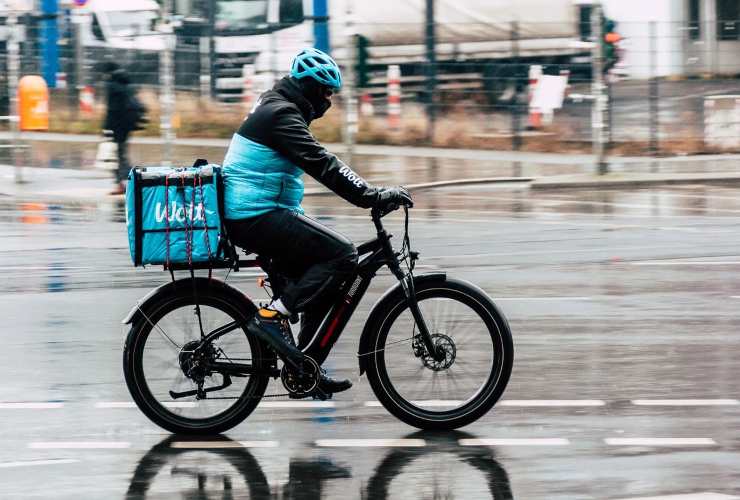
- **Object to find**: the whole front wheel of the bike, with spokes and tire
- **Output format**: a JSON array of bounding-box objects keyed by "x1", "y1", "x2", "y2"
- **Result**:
[{"x1": 368, "y1": 279, "x2": 514, "y2": 430}]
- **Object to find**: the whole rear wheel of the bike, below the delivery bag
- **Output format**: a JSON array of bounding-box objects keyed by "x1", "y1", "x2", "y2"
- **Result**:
[{"x1": 124, "y1": 286, "x2": 269, "y2": 434}]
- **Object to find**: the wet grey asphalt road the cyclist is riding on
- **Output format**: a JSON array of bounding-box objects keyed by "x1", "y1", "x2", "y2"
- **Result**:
[{"x1": 0, "y1": 174, "x2": 740, "y2": 500}]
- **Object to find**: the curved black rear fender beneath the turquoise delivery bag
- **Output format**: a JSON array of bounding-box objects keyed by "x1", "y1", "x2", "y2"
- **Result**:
[{"x1": 121, "y1": 278, "x2": 257, "y2": 325}]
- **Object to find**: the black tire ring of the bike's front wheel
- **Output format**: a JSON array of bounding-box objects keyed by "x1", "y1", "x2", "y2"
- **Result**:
[{"x1": 367, "y1": 278, "x2": 514, "y2": 430}]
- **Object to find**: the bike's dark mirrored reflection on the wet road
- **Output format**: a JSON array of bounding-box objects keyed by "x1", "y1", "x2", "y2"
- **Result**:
[{"x1": 125, "y1": 432, "x2": 514, "y2": 500}]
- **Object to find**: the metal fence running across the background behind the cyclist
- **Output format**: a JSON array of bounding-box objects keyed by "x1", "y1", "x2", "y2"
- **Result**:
[{"x1": 0, "y1": 7, "x2": 740, "y2": 167}]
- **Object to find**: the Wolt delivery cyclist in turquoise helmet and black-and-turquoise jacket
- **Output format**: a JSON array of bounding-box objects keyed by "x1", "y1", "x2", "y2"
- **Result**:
[{"x1": 223, "y1": 48, "x2": 413, "y2": 394}]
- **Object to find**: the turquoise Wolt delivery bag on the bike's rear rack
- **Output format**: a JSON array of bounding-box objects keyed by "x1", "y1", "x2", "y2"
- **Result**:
[{"x1": 126, "y1": 160, "x2": 227, "y2": 270}]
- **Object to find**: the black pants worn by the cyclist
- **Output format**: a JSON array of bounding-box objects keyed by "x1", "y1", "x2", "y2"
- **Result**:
[{"x1": 226, "y1": 209, "x2": 357, "y2": 313}]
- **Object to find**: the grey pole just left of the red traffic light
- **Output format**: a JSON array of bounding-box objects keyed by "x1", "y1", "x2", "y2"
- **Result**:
[{"x1": 591, "y1": 3, "x2": 609, "y2": 175}]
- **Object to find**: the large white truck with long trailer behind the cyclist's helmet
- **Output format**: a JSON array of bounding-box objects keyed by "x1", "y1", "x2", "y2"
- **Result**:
[{"x1": 176, "y1": 0, "x2": 591, "y2": 101}]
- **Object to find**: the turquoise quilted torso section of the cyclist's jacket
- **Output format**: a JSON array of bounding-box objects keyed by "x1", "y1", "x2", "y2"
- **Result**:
[{"x1": 223, "y1": 134, "x2": 303, "y2": 219}]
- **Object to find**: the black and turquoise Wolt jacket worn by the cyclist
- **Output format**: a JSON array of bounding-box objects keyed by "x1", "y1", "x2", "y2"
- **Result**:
[{"x1": 224, "y1": 77, "x2": 380, "y2": 219}]
